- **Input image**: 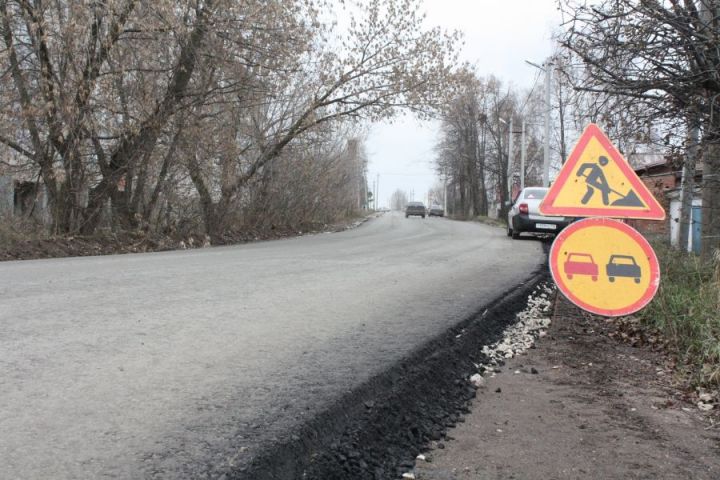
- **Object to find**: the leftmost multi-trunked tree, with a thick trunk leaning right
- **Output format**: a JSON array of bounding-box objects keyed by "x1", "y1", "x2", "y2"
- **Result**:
[{"x1": 0, "y1": 0, "x2": 219, "y2": 232}]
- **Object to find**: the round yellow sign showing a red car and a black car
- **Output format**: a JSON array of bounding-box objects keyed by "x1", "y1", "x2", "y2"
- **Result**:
[{"x1": 550, "y1": 218, "x2": 660, "y2": 317}]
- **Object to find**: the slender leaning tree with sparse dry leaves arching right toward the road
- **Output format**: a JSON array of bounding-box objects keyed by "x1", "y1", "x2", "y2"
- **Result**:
[{"x1": 186, "y1": 0, "x2": 458, "y2": 232}]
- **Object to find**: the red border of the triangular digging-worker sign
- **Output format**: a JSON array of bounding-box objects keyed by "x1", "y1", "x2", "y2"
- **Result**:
[{"x1": 540, "y1": 123, "x2": 665, "y2": 220}]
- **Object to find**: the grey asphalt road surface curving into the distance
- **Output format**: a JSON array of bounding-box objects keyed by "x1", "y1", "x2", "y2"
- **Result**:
[{"x1": 0, "y1": 214, "x2": 543, "y2": 479}]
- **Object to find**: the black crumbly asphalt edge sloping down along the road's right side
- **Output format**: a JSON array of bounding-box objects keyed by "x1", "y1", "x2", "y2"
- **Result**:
[{"x1": 228, "y1": 268, "x2": 548, "y2": 480}]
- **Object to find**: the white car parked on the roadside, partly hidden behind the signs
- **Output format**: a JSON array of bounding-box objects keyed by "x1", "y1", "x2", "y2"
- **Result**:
[{"x1": 507, "y1": 187, "x2": 573, "y2": 238}]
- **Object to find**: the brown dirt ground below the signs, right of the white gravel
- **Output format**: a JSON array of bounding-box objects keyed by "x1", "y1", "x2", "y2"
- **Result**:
[{"x1": 414, "y1": 299, "x2": 720, "y2": 480}]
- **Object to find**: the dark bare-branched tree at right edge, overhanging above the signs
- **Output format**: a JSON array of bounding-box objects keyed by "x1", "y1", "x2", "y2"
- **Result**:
[{"x1": 561, "y1": 0, "x2": 720, "y2": 258}]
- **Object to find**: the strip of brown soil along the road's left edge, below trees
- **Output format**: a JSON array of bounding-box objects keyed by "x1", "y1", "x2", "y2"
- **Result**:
[{"x1": 0, "y1": 214, "x2": 375, "y2": 261}]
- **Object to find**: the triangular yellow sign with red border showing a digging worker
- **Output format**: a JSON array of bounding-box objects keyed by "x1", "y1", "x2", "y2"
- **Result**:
[{"x1": 540, "y1": 123, "x2": 665, "y2": 220}]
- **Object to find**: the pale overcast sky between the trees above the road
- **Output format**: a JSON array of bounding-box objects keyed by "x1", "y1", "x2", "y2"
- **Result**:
[{"x1": 366, "y1": 0, "x2": 560, "y2": 207}]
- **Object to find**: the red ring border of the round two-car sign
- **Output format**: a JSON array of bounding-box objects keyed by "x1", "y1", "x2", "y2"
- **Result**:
[{"x1": 550, "y1": 218, "x2": 660, "y2": 317}]
